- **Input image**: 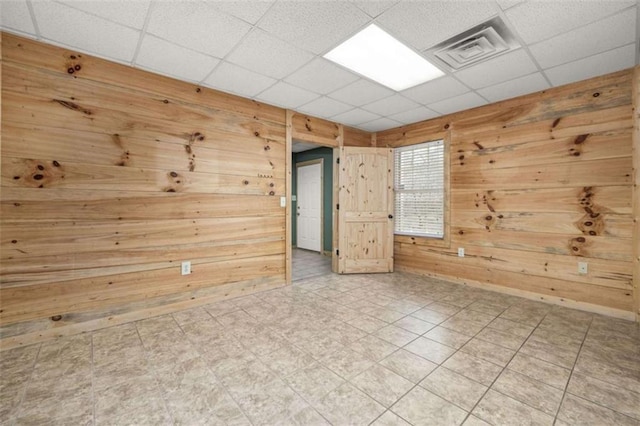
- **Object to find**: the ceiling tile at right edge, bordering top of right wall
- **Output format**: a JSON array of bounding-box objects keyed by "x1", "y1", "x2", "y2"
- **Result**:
[{"x1": 544, "y1": 44, "x2": 636, "y2": 86}]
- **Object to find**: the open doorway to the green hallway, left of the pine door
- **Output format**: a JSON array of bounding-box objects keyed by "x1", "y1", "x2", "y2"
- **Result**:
[{"x1": 291, "y1": 140, "x2": 334, "y2": 281}]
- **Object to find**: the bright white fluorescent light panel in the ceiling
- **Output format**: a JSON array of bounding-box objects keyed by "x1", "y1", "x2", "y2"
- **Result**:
[{"x1": 324, "y1": 24, "x2": 444, "y2": 91}]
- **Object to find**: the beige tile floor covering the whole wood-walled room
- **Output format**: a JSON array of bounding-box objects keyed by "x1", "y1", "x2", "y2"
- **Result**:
[{"x1": 0, "y1": 273, "x2": 640, "y2": 426}]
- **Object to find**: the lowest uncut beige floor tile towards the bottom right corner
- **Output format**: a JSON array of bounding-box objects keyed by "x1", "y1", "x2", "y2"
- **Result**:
[{"x1": 491, "y1": 369, "x2": 563, "y2": 416}]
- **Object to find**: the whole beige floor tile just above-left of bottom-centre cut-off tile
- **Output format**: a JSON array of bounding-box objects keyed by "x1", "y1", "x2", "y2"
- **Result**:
[{"x1": 284, "y1": 363, "x2": 345, "y2": 403}]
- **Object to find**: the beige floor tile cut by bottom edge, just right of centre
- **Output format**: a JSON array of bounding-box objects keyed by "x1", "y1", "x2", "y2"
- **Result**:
[{"x1": 316, "y1": 383, "x2": 385, "y2": 425}]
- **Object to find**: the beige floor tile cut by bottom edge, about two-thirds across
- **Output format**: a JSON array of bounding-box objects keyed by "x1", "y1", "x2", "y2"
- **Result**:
[{"x1": 391, "y1": 386, "x2": 467, "y2": 426}]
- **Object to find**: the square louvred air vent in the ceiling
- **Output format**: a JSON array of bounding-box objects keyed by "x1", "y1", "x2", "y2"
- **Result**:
[{"x1": 425, "y1": 17, "x2": 520, "y2": 71}]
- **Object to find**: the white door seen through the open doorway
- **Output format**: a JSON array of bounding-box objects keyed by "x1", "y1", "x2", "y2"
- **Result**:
[{"x1": 296, "y1": 162, "x2": 322, "y2": 252}]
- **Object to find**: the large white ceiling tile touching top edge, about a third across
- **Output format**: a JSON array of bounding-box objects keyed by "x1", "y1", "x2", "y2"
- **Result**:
[{"x1": 147, "y1": 1, "x2": 251, "y2": 58}]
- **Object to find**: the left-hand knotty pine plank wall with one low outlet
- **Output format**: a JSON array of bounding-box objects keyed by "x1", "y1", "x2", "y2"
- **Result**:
[{"x1": 0, "y1": 34, "x2": 287, "y2": 346}]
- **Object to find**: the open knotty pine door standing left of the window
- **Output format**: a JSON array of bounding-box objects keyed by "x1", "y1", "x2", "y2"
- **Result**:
[{"x1": 338, "y1": 147, "x2": 393, "y2": 274}]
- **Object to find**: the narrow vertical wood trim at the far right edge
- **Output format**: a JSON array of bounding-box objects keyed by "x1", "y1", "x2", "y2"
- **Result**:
[{"x1": 631, "y1": 65, "x2": 640, "y2": 322}]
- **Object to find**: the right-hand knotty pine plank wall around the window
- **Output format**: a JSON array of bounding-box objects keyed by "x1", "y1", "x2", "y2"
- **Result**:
[{"x1": 376, "y1": 70, "x2": 638, "y2": 317}]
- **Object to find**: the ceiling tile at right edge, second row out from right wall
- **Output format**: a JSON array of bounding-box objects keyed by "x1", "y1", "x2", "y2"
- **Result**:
[{"x1": 530, "y1": 9, "x2": 636, "y2": 68}]
